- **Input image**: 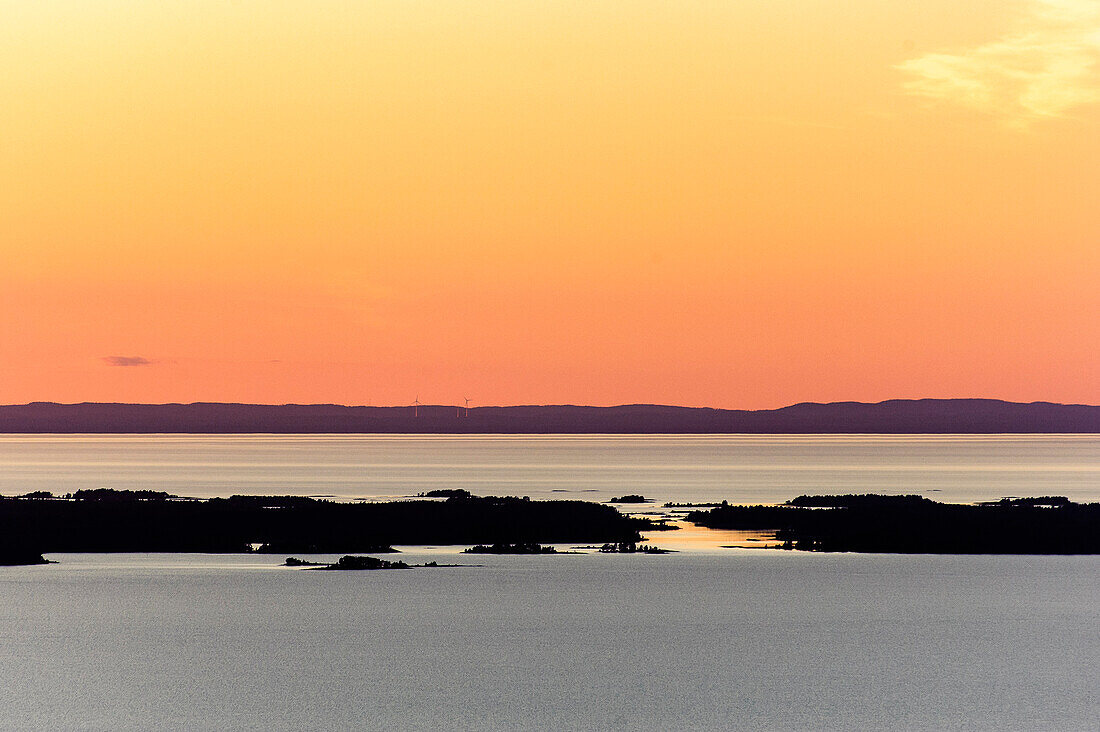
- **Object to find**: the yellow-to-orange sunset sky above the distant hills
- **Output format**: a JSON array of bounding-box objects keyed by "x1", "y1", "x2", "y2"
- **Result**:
[{"x1": 0, "y1": 0, "x2": 1100, "y2": 408}]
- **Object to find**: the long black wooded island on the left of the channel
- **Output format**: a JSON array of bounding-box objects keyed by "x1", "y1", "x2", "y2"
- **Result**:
[{"x1": 0, "y1": 491, "x2": 650, "y2": 554}]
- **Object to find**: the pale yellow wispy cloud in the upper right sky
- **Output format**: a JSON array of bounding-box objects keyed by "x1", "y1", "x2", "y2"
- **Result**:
[{"x1": 897, "y1": 0, "x2": 1100, "y2": 127}]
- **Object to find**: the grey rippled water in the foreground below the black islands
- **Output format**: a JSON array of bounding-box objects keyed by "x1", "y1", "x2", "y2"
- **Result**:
[{"x1": 0, "y1": 549, "x2": 1100, "y2": 730}]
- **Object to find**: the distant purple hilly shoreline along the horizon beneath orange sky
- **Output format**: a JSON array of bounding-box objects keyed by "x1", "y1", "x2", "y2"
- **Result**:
[{"x1": 0, "y1": 398, "x2": 1100, "y2": 434}]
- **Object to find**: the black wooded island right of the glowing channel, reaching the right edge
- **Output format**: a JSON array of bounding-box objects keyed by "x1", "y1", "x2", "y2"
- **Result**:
[{"x1": 686, "y1": 495, "x2": 1100, "y2": 554}]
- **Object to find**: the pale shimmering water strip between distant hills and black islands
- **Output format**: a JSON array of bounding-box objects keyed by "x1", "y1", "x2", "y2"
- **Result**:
[{"x1": 0, "y1": 435, "x2": 1100, "y2": 503}]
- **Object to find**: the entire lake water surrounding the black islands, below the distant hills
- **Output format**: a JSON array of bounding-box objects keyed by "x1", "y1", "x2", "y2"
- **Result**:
[{"x1": 0, "y1": 435, "x2": 1100, "y2": 730}]
